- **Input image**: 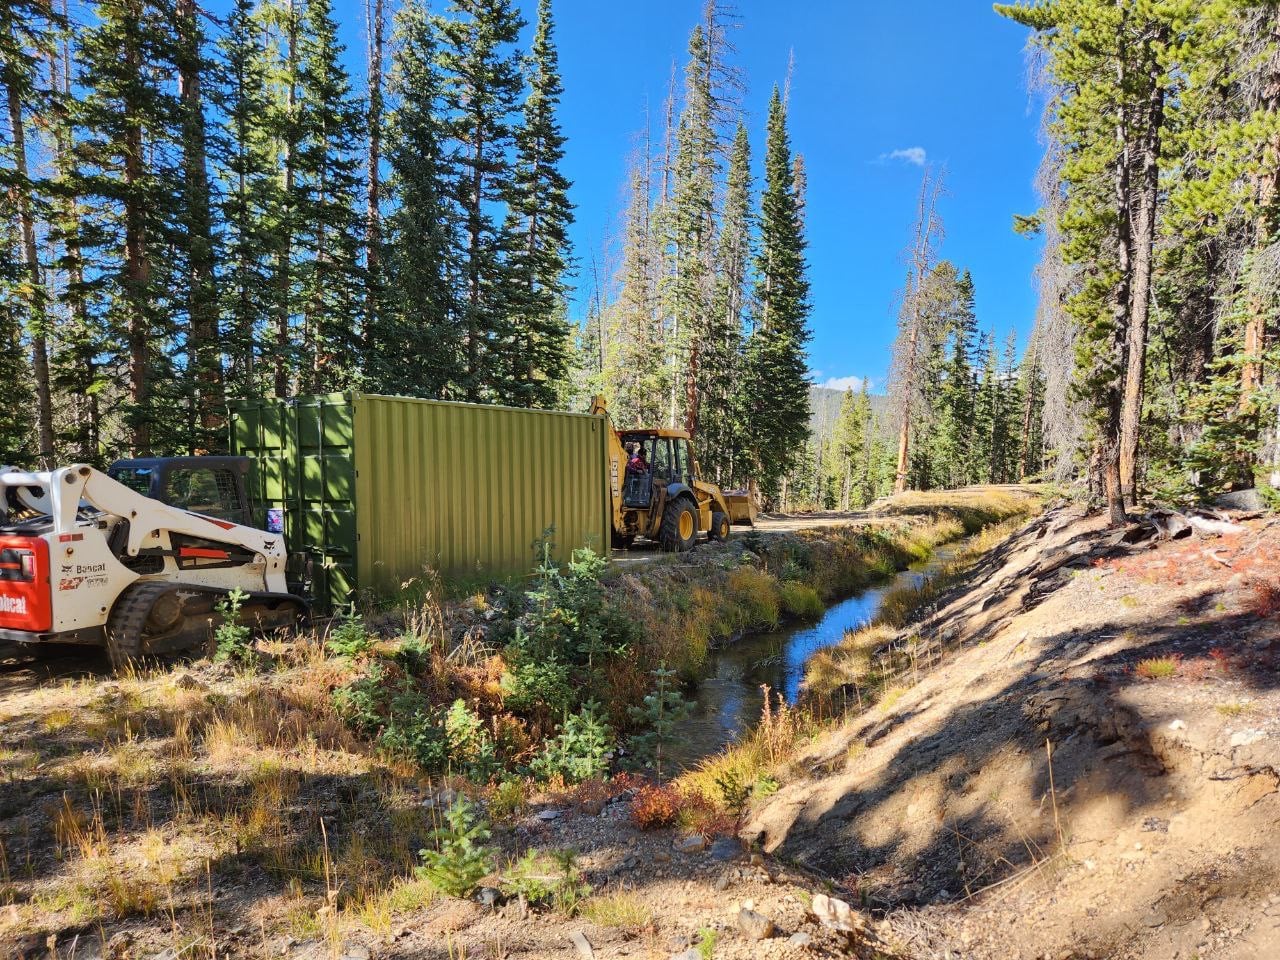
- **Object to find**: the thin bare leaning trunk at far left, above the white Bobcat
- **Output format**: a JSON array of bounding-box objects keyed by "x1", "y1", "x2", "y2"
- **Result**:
[{"x1": 4, "y1": 28, "x2": 54, "y2": 467}]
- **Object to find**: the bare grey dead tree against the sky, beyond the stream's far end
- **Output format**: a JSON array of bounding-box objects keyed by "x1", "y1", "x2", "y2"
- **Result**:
[{"x1": 892, "y1": 168, "x2": 943, "y2": 493}]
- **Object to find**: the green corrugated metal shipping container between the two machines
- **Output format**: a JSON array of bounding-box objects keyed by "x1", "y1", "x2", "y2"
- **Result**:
[{"x1": 230, "y1": 393, "x2": 609, "y2": 609}]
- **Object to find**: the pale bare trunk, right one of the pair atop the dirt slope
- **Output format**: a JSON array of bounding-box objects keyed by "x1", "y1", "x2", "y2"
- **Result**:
[{"x1": 1120, "y1": 31, "x2": 1165, "y2": 507}]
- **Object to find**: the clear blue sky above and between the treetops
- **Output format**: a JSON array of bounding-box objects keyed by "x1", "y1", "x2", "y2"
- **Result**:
[{"x1": 257, "y1": 0, "x2": 1041, "y2": 389}]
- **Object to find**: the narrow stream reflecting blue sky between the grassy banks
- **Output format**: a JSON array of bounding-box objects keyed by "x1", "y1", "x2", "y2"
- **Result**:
[{"x1": 671, "y1": 540, "x2": 964, "y2": 767}]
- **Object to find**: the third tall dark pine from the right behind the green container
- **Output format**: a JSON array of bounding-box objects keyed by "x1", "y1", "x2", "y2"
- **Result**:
[{"x1": 376, "y1": 0, "x2": 463, "y2": 398}]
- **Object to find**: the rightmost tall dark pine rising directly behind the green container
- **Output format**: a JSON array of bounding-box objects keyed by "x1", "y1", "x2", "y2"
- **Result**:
[{"x1": 499, "y1": 0, "x2": 573, "y2": 407}]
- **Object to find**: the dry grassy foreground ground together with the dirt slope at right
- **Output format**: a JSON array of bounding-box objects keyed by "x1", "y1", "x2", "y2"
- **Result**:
[{"x1": 10, "y1": 488, "x2": 1280, "y2": 960}]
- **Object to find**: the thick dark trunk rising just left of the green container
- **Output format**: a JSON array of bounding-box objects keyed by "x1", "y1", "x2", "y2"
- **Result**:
[{"x1": 175, "y1": 0, "x2": 227, "y2": 453}]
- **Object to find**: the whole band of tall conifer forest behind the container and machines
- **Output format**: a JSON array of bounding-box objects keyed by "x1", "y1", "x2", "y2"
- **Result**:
[{"x1": 0, "y1": 0, "x2": 1280, "y2": 520}]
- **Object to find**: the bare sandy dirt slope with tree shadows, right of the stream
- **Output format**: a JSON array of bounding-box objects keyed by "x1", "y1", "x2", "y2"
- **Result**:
[{"x1": 748, "y1": 507, "x2": 1280, "y2": 960}]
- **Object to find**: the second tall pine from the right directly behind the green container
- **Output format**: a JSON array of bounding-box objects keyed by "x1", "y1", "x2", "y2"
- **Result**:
[{"x1": 435, "y1": 0, "x2": 524, "y2": 402}]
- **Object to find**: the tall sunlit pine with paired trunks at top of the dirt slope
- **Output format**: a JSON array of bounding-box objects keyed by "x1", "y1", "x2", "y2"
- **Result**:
[{"x1": 996, "y1": 0, "x2": 1175, "y2": 524}]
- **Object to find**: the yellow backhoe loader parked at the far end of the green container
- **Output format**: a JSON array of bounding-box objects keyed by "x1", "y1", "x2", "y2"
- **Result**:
[{"x1": 591, "y1": 397, "x2": 755, "y2": 552}]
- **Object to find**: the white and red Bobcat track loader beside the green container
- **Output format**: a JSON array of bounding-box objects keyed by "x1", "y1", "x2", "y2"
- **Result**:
[{"x1": 0, "y1": 458, "x2": 306, "y2": 666}]
